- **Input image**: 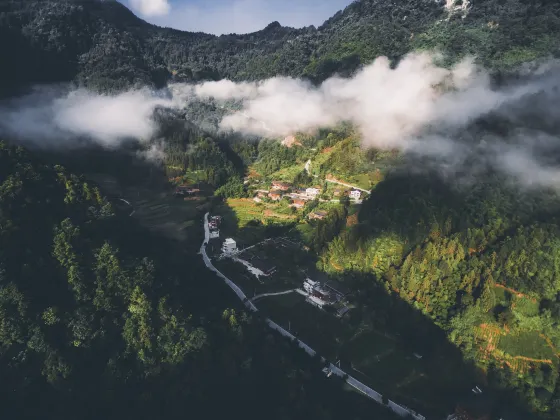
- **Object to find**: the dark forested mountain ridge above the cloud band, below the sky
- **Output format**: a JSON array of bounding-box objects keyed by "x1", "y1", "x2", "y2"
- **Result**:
[{"x1": 0, "y1": 0, "x2": 560, "y2": 95}]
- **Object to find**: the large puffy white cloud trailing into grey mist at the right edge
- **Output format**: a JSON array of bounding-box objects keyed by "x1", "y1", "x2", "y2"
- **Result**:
[{"x1": 184, "y1": 53, "x2": 560, "y2": 189}]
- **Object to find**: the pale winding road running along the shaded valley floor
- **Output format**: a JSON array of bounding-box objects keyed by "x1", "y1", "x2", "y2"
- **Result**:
[{"x1": 200, "y1": 213, "x2": 426, "y2": 420}]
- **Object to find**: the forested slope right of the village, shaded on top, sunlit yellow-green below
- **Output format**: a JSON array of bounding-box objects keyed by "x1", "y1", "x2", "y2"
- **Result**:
[{"x1": 321, "y1": 170, "x2": 560, "y2": 417}]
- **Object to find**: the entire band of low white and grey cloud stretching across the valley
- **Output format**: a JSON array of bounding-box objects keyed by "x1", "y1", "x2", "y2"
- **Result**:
[{"x1": 0, "y1": 53, "x2": 560, "y2": 187}]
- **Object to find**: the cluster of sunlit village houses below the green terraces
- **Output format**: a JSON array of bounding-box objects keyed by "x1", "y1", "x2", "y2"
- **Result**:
[{"x1": 253, "y1": 181, "x2": 362, "y2": 209}]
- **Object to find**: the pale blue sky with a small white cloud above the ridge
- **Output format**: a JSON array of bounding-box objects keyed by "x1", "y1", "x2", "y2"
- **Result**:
[{"x1": 119, "y1": 0, "x2": 352, "y2": 35}]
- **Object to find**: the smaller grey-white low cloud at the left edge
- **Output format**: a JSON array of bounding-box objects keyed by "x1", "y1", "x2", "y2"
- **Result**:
[{"x1": 0, "y1": 88, "x2": 173, "y2": 147}]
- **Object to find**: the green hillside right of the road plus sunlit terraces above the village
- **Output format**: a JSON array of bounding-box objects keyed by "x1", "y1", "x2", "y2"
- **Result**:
[{"x1": 224, "y1": 127, "x2": 560, "y2": 419}]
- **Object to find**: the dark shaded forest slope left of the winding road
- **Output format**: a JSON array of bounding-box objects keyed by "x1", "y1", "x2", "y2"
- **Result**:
[{"x1": 0, "y1": 143, "x2": 404, "y2": 419}]
